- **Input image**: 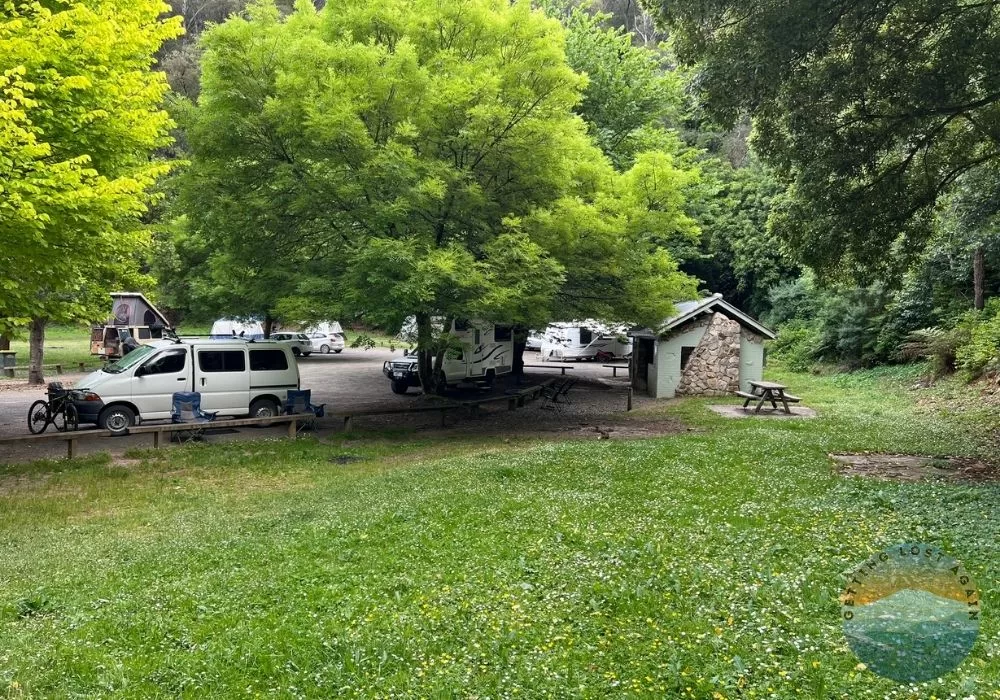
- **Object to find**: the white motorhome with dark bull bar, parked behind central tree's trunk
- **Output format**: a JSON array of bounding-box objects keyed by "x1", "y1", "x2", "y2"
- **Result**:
[{"x1": 382, "y1": 319, "x2": 514, "y2": 394}]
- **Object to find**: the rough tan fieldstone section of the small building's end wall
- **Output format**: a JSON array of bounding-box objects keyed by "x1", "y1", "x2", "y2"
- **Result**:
[{"x1": 677, "y1": 313, "x2": 741, "y2": 396}]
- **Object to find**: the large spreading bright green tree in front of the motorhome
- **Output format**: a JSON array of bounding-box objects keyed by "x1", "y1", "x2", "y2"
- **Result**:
[{"x1": 185, "y1": 0, "x2": 687, "y2": 389}]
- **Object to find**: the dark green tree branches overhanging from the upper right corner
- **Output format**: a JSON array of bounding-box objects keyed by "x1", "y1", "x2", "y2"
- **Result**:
[{"x1": 647, "y1": 0, "x2": 1000, "y2": 278}]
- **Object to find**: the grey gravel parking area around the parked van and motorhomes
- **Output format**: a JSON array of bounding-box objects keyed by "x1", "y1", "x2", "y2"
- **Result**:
[{"x1": 0, "y1": 348, "x2": 648, "y2": 463}]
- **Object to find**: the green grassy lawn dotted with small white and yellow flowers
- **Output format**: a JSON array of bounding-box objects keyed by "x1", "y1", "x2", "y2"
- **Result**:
[{"x1": 0, "y1": 371, "x2": 1000, "y2": 699}]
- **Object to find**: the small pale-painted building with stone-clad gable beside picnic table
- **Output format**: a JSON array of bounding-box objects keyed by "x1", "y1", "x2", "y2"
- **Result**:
[{"x1": 629, "y1": 294, "x2": 774, "y2": 399}]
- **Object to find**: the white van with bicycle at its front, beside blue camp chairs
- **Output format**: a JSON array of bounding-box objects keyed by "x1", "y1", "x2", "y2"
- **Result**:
[{"x1": 73, "y1": 338, "x2": 299, "y2": 433}]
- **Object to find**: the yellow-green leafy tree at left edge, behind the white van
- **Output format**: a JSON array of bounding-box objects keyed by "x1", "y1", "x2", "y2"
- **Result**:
[{"x1": 0, "y1": 0, "x2": 180, "y2": 383}]
